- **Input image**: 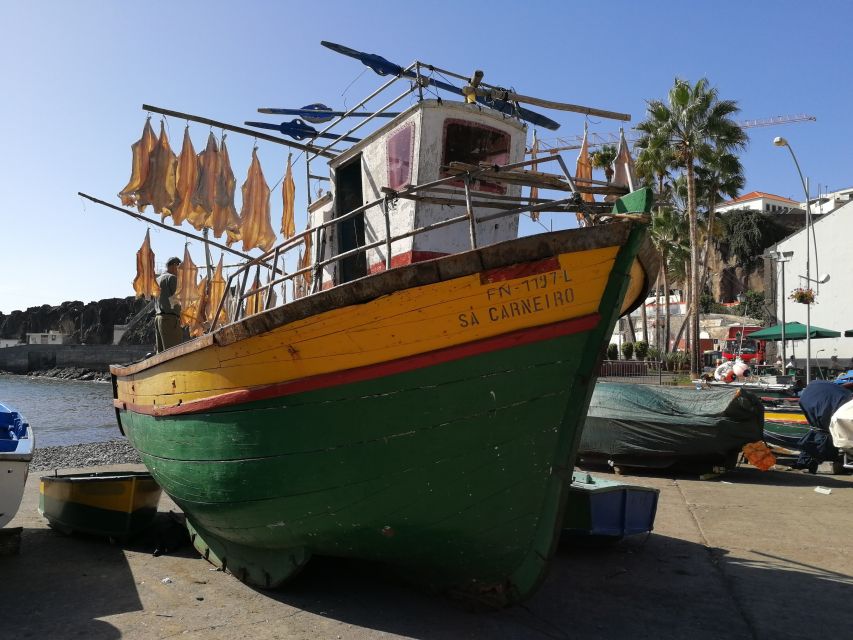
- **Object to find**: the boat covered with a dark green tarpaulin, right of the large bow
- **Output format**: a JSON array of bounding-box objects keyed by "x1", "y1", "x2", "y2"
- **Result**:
[{"x1": 579, "y1": 382, "x2": 764, "y2": 468}]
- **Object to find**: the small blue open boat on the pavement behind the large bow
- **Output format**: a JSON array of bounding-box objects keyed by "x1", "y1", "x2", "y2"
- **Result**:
[{"x1": 563, "y1": 471, "x2": 660, "y2": 540}]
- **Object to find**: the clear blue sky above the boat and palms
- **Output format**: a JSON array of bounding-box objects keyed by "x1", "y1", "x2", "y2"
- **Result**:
[{"x1": 0, "y1": 0, "x2": 853, "y2": 313}]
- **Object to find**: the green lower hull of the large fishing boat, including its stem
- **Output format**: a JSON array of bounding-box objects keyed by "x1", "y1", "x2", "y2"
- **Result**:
[{"x1": 119, "y1": 230, "x2": 644, "y2": 605}]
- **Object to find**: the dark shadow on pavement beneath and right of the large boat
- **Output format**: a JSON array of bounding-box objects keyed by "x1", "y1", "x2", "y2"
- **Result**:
[{"x1": 253, "y1": 534, "x2": 853, "y2": 640}]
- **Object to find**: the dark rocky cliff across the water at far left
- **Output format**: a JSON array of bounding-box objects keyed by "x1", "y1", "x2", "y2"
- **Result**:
[{"x1": 0, "y1": 296, "x2": 154, "y2": 344}]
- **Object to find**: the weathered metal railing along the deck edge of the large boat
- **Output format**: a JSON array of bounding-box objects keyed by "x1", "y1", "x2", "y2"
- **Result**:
[{"x1": 208, "y1": 154, "x2": 630, "y2": 331}]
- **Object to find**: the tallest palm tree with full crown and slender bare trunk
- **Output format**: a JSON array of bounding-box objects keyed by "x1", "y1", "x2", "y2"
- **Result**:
[{"x1": 637, "y1": 78, "x2": 746, "y2": 376}]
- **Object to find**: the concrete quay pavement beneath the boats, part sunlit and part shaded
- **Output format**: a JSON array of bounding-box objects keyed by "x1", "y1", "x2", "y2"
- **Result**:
[{"x1": 0, "y1": 466, "x2": 853, "y2": 640}]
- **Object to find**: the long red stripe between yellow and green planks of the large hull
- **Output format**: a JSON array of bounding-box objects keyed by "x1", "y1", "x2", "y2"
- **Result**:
[{"x1": 114, "y1": 313, "x2": 601, "y2": 416}]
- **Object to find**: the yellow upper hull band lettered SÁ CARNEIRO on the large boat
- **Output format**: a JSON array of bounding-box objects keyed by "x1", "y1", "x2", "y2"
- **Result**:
[{"x1": 117, "y1": 246, "x2": 620, "y2": 406}]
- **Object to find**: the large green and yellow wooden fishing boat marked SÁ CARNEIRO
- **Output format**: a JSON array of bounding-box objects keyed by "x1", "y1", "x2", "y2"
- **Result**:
[{"x1": 105, "y1": 41, "x2": 657, "y2": 604}]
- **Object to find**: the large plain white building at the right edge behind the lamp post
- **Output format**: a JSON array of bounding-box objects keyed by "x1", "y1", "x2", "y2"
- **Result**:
[{"x1": 767, "y1": 202, "x2": 853, "y2": 367}]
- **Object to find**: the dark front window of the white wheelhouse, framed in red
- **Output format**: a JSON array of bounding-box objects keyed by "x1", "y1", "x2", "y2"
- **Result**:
[{"x1": 441, "y1": 119, "x2": 510, "y2": 193}]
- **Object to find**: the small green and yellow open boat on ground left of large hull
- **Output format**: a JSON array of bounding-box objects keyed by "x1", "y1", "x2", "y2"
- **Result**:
[{"x1": 39, "y1": 471, "x2": 162, "y2": 538}]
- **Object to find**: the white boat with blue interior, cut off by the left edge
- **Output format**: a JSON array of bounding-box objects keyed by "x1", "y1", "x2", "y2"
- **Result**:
[{"x1": 0, "y1": 404, "x2": 35, "y2": 528}]
